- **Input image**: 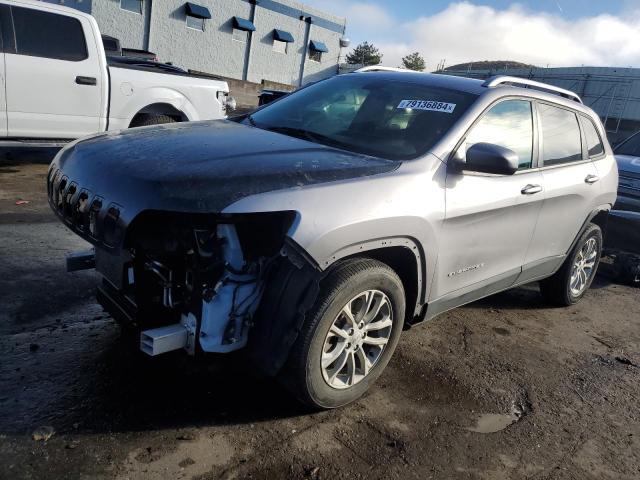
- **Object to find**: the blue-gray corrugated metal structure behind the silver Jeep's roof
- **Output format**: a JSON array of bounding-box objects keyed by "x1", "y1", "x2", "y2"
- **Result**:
[{"x1": 439, "y1": 67, "x2": 640, "y2": 142}]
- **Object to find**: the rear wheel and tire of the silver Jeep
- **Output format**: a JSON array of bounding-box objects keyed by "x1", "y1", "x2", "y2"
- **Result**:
[{"x1": 540, "y1": 223, "x2": 602, "y2": 307}]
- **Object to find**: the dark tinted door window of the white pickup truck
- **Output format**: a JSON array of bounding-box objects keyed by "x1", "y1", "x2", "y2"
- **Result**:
[{"x1": 11, "y1": 7, "x2": 88, "y2": 62}]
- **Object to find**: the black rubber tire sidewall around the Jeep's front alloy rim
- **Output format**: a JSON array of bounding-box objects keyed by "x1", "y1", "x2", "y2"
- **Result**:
[{"x1": 304, "y1": 268, "x2": 405, "y2": 408}]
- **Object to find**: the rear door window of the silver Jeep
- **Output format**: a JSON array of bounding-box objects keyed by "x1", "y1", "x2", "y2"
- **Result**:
[{"x1": 538, "y1": 103, "x2": 582, "y2": 166}]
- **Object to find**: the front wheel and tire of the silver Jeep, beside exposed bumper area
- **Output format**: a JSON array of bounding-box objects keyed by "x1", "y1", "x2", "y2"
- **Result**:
[{"x1": 280, "y1": 259, "x2": 405, "y2": 409}]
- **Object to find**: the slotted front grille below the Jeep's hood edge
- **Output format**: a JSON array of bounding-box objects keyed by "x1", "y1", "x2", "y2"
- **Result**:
[{"x1": 47, "y1": 168, "x2": 122, "y2": 248}]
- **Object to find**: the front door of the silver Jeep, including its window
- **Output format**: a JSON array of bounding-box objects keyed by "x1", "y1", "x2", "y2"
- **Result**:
[{"x1": 431, "y1": 99, "x2": 544, "y2": 302}]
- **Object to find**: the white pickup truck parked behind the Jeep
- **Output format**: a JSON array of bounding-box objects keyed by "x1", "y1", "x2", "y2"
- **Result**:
[{"x1": 0, "y1": 0, "x2": 234, "y2": 143}]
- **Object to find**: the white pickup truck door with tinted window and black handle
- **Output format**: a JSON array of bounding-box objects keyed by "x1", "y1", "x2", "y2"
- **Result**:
[{"x1": 4, "y1": 4, "x2": 107, "y2": 139}]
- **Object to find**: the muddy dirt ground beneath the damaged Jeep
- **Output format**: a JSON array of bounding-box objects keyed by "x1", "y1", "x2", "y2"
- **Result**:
[{"x1": 0, "y1": 159, "x2": 640, "y2": 480}]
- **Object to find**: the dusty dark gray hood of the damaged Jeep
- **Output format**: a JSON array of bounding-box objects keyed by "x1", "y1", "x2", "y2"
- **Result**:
[{"x1": 49, "y1": 120, "x2": 400, "y2": 249}]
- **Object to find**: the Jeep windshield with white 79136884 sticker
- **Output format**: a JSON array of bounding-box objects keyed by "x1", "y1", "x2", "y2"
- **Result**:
[{"x1": 248, "y1": 73, "x2": 477, "y2": 160}]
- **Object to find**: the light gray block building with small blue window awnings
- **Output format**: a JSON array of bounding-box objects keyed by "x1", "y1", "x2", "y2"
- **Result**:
[{"x1": 45, "y1": 0, "x2": 346, "y2": 86}]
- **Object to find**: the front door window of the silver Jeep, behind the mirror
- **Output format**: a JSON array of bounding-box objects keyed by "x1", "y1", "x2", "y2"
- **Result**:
[{"x1": 466, "y1": 100, "x2": 533, "y2": 170}]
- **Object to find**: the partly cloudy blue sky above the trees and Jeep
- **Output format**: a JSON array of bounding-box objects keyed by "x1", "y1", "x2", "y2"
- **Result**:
[{"x1": 302, "y1": 0, "x2": 640, "y2": 68}]
